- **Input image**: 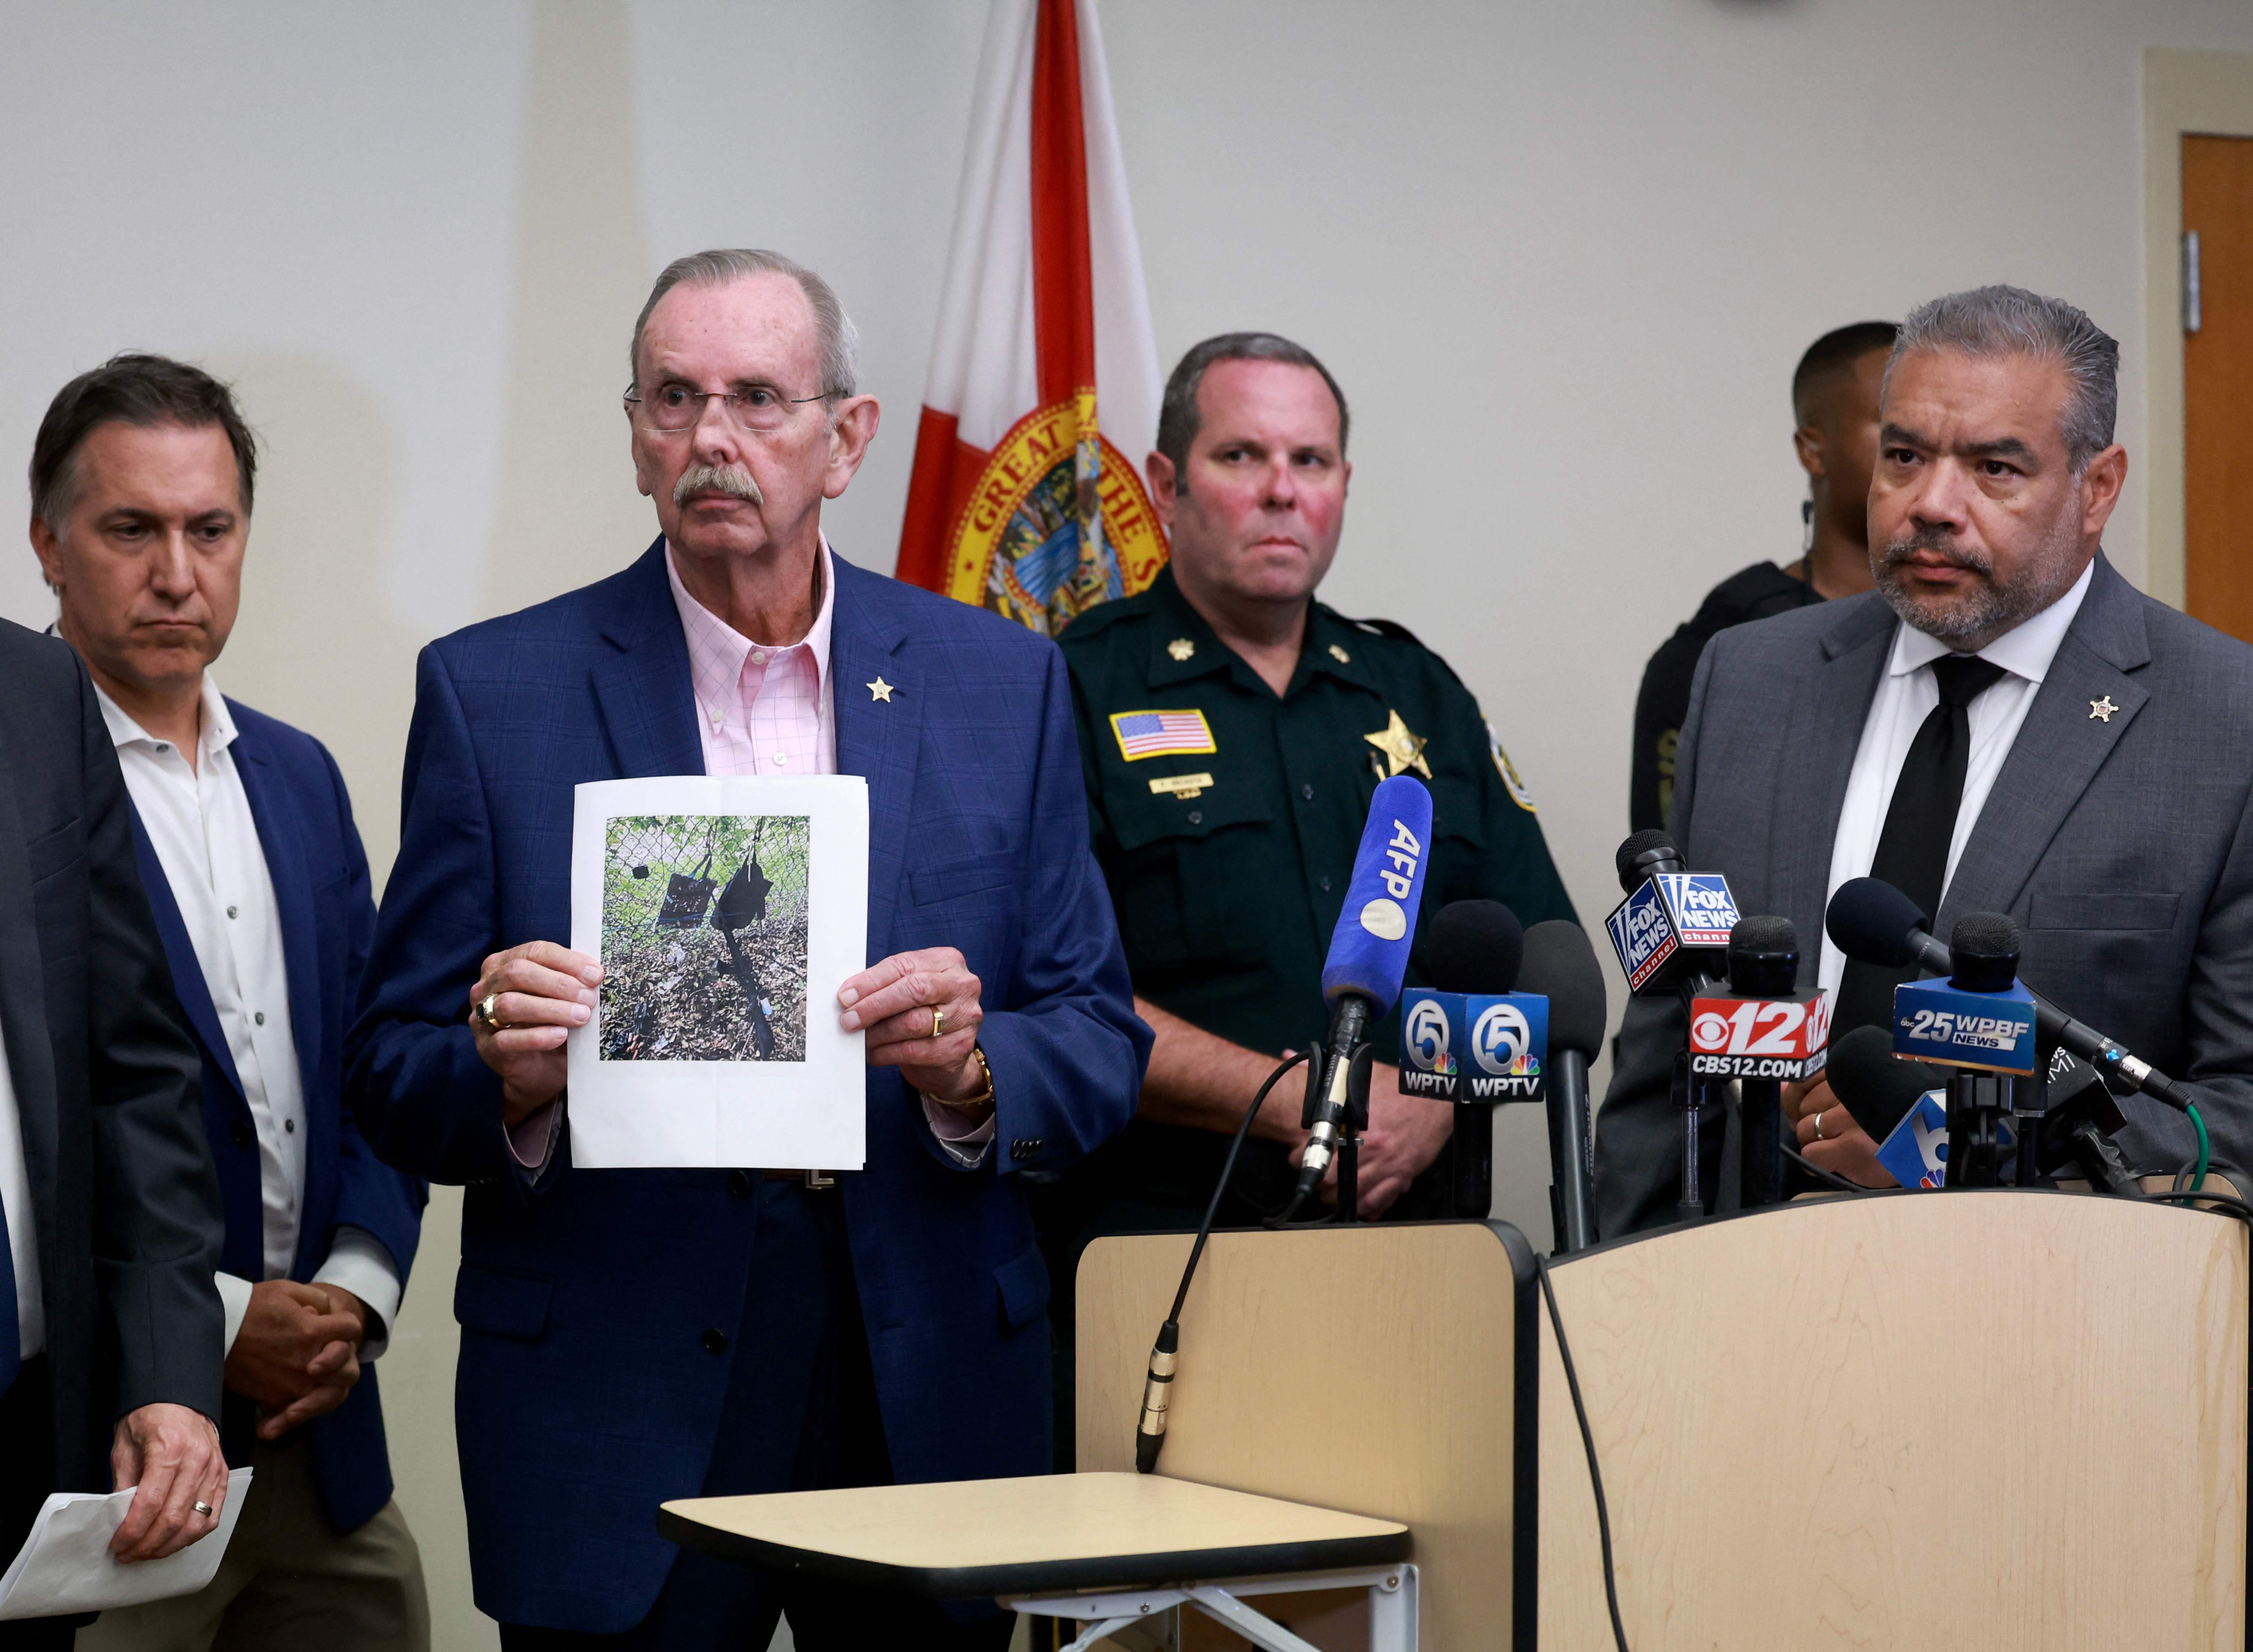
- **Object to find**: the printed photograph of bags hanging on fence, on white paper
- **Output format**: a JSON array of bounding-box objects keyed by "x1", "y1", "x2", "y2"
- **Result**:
[{"x1": 597, "y1": 814, "x2": 813, "y2": 1061}]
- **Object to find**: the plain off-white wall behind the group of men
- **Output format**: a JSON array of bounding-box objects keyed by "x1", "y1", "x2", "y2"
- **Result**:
[{"x1": 17, "y1": 0, "x2": 2253, "y2": 1645}]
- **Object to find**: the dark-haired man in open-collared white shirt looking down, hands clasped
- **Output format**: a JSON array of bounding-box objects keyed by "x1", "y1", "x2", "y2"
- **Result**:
[{"x1": 32, "y1": 356, "x2": 430, "y2": 1652}]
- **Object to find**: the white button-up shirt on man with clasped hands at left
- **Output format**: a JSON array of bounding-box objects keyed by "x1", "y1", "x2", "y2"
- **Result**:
[{"x1": 95, "y1": 672, "x2": 401, "y2": 1359}]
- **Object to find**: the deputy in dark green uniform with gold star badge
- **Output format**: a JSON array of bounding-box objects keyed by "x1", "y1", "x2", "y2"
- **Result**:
[{"x1": 1043, "y1": 333, "x2": 1573, "y2": 1451}]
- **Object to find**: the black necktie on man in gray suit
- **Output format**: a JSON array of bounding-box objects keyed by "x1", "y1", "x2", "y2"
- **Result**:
[{"x1": 1832, "y1": 654, "x2": 2003, "y2": 1041}]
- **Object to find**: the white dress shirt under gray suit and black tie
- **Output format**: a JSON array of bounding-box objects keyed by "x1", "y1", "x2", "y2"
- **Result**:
[{"x1": 1816, "y1": 559, "x2": 2095, "y2": 994}]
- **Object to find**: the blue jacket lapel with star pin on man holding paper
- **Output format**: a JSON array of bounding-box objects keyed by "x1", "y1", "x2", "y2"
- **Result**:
[{"x1": 829, "y1": 557, "x2": 928, "y2": 960}]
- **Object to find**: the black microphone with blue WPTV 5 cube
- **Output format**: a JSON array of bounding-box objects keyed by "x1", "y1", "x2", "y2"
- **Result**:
[{"x1": 1401, "y1": 901, "x2": 1546, "y2": 1219}]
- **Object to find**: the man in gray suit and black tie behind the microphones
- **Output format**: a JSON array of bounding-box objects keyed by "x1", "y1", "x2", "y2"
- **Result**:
[{"x1": 1595, "y1": 286, "x2": 2253, "y2": 1237}]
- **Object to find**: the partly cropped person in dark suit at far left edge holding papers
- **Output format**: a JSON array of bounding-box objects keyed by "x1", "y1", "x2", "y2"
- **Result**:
[{"x1": 0, "y1": 622, "x2": 228, "y2": 1650}]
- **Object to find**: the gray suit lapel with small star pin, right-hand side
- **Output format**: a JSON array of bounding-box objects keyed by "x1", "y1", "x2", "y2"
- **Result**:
[{"x1": 1933, "y1": 555, "x2": 2152, "y2": 935}]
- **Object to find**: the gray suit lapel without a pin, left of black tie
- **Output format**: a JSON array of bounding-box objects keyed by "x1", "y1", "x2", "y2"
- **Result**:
[{"x1": 1769, "y1": 597, "x2": 1895, "y2": 967}]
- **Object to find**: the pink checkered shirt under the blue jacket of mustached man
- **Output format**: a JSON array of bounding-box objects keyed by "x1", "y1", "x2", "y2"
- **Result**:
[{"x1": 665, "y1": 539, "x2": 838, "y2": 775}]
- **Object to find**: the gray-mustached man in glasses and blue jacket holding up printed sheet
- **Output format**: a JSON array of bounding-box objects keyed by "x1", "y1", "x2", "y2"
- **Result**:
[{"x1": 349, "y1": 252, "x2": 1149, "y2": 1652}]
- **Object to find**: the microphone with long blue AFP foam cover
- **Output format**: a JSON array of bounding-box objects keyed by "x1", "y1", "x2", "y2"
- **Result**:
[{"x1": 1291, "y1": 775, "x2": 1431, "y2": 1221}]
